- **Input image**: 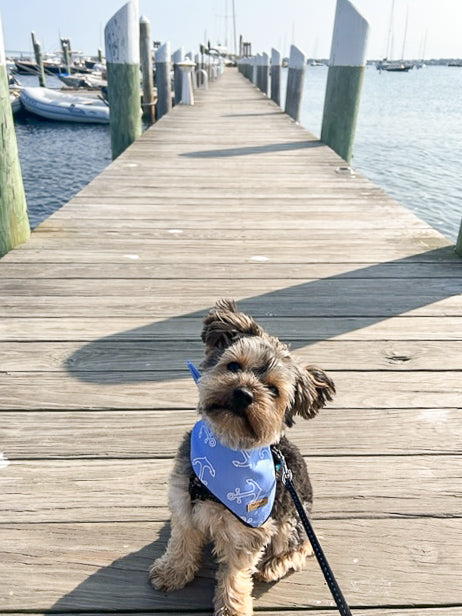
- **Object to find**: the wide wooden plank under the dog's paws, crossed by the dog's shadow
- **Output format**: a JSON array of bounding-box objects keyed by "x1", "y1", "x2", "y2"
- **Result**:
[{"x1": 0, "y1": 518, "x2": 462, "y2": 614}]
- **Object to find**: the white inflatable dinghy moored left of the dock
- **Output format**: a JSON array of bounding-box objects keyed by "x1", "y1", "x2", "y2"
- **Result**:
[{"x1": 21, "y1": 87, "x2": 109, "y2": 124}]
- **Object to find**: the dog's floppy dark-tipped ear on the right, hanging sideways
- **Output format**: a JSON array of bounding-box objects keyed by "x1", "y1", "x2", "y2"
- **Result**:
[{"x1": 284, "y1": 366, "x2": 335, "y2": 428}]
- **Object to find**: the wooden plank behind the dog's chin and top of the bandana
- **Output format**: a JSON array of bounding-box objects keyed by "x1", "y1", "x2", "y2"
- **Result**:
[{"x1": 0, "y1": 408, "x2": 462, "y2": 458}]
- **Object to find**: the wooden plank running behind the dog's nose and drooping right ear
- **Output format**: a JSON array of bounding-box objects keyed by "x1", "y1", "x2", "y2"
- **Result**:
[{"x1": 0, "y1": 370, "x2": 462, "y2": 410}]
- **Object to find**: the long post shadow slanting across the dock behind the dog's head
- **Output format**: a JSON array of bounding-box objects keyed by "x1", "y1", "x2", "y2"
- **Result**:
[{"x1": 66, "y1": 246, "x2": 462, "y2": 385}]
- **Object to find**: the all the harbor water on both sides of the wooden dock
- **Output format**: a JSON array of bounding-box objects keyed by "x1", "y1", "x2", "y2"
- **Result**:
[{"x1": 12, "y1": 67, "x2": 462, "y2": 240}]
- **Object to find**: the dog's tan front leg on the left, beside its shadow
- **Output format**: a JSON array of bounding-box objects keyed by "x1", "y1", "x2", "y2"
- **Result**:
[{"x1": 149, "y1": 516, "x2": 205, "y2": 592}]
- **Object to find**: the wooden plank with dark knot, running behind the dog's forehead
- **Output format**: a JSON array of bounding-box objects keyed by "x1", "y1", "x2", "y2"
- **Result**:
[{"x1": 0, "y1": 338, "x2": 462, "y2": 372}]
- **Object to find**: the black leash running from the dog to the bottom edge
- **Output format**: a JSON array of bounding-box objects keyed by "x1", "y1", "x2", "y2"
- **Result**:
[{"x1": 271, "y1": 447, "x2": 353, "y2": 616}]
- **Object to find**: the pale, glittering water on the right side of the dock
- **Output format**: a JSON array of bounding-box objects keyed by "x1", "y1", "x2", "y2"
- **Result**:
[{"x1": 283, "y1": 66, "x2": 462, "y2": 241}]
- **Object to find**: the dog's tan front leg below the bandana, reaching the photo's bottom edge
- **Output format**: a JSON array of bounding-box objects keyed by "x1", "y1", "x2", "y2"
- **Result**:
[{"x1": 214, "y1": 522, "x2": 267, "y2": 616}]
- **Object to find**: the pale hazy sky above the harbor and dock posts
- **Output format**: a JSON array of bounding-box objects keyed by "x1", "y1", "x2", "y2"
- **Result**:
[{"x1": 0, "y1": 0, "x2": 462, "y2": 58}]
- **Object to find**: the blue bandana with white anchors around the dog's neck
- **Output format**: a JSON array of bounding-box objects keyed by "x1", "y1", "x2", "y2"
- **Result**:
[{"x1": 191, "y1": 419, "x2": 276, "y2": 528}]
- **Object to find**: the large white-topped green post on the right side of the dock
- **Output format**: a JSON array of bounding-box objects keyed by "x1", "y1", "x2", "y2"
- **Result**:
[{"x1": 321, "y1": 0, "x2": 369, "y2": 163}]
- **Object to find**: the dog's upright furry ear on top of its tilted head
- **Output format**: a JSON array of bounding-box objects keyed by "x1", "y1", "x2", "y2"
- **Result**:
[{"x1": 202, "y1": 299, "x2": 264, "y2": 353}]
